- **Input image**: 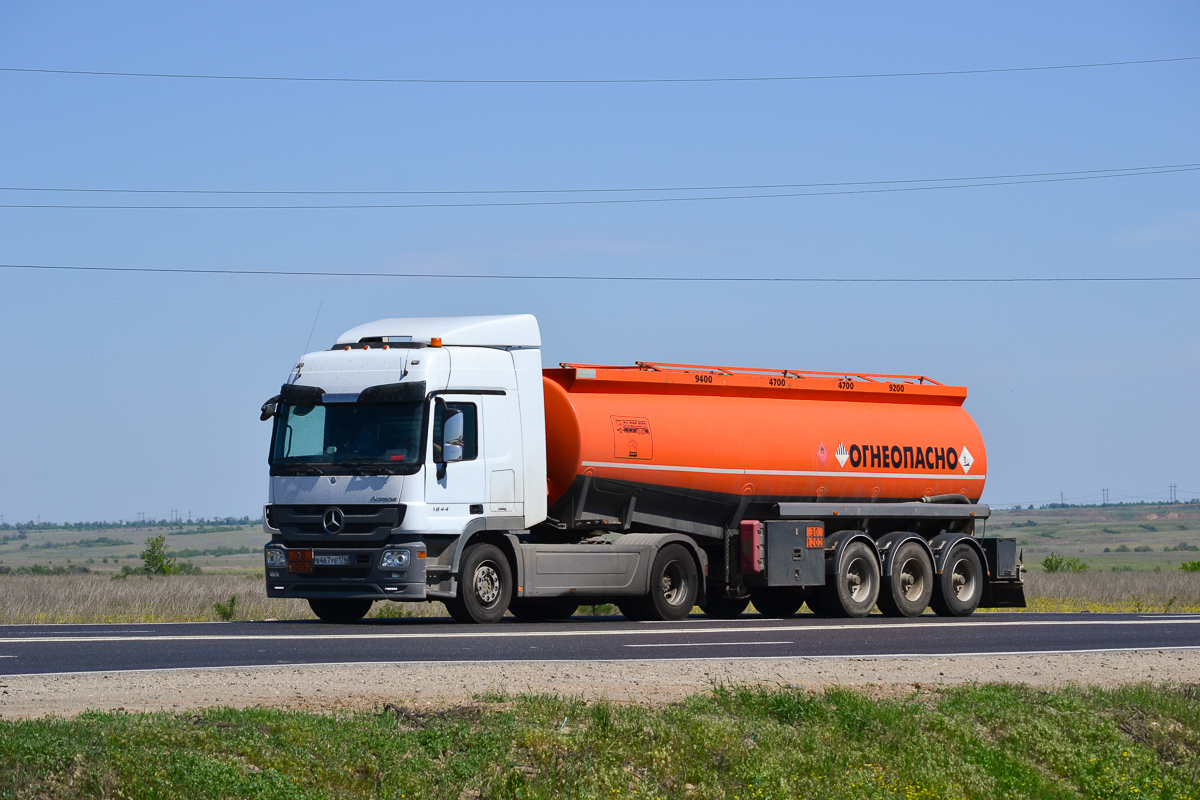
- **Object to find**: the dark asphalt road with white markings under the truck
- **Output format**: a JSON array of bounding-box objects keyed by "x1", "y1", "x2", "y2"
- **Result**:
[{"x1": 0, "y1": 613, "x2": 1200, "y2": 675}]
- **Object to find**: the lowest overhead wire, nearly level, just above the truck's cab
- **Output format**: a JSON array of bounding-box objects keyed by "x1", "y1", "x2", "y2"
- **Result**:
[{"x1": 0, "y1": 264, "x2": 1200, "y2": 283}]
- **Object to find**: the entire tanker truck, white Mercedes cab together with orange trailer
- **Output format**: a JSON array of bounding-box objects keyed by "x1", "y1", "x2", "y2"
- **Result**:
[{"x1": 262, "y1": 314, "x2": 1025, "y2": 622}]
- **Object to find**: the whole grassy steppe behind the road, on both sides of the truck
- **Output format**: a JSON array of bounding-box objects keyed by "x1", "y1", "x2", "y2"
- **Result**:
[{"x1": 0, "y1": 503, "x2": 1200, "y2": 624}]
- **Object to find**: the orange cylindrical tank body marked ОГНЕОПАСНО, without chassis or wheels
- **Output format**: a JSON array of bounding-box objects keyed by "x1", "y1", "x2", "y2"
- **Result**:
[{"x1": 542, "y1": 362, "x2": 988, "y2": 535}]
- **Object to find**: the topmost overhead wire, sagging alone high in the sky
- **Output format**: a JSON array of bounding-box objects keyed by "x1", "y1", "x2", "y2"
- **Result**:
[{"x1": 0, "y1": 55, "x2": 1200, "y2": 85}]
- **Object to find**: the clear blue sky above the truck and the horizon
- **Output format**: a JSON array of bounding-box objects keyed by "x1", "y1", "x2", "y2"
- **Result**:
[{"x1": 0, "y1": 0, "x2": 1200, "y2": 522}]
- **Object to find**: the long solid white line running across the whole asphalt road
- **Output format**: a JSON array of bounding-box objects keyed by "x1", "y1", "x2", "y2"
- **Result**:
[{"x1": 0, "y1": 614, "x2": 1200, "y2": 644}]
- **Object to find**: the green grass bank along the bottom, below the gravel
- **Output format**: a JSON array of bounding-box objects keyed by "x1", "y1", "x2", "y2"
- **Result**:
[{"x1": 0, "y1": 685, "x2": 1200, "y2": 800}]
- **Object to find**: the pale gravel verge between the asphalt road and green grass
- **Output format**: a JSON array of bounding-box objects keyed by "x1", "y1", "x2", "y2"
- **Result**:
[{"x1": 0, "y1": 650, "x2": 1200, "y2": 720}]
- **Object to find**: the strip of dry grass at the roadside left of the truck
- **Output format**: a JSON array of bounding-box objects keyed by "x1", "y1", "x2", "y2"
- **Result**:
[{"x1": 0, "y1": 575, "x2": 445, "y2": 625}]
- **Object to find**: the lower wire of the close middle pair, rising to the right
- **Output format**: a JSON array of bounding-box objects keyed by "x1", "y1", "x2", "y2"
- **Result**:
[{"x1": 0, "y1": 166, "x2": 1200, "y2": 211}]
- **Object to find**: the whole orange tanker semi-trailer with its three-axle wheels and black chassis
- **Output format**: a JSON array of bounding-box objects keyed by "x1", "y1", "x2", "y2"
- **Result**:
[{"x1": 542, "y1": 362, "x2": 1024, "y2": 616}]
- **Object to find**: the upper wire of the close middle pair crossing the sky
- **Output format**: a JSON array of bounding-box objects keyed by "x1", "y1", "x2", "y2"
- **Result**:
[{"x1": 0, "y1": 162, "x2": 1200, "y2": 196}]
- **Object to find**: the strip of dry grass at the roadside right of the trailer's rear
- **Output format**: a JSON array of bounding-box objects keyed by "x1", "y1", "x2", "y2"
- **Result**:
[{"x1": 1025, "y1": 570, "x2": 1200, "y2": 613}]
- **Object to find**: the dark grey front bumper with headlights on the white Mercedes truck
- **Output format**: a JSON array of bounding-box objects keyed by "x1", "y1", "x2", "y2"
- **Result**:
[{"x1": 264, "y1": 542, "x2": 426, "y2": 601}]
